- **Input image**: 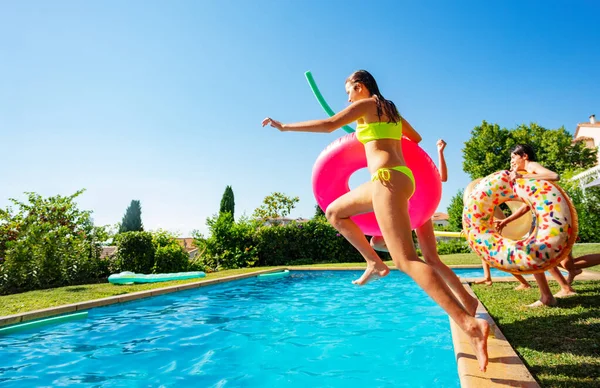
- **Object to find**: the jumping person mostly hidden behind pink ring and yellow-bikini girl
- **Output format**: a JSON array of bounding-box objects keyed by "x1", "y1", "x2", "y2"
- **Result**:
[{"x1": 371, "y1": 139, "x2": 479, "y2": 316}]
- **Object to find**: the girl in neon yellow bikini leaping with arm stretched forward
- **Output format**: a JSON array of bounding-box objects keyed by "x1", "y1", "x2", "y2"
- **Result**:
[{"x1": 262, "y1": 70, "x2": 489, "y2": 371}]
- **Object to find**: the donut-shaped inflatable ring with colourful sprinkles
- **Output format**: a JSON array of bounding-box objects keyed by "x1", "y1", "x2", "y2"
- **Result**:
[{"x1": 463, "y1": 171, "x2": 577, "y2": 274}]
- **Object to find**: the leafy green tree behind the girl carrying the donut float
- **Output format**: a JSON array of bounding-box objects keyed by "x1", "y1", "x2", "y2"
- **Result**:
[{"x1": 463, "y1": 121, "x2": 597, "y2": 179}]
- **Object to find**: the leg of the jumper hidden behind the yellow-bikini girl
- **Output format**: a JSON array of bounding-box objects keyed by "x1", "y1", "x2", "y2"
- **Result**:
[{"x1": 416, "y1": 221, "x2": 479, "y2": 317}]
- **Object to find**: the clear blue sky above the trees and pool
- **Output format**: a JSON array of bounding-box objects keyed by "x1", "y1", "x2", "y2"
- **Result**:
[{"x1": 0, "y1": 0, "x2": 600, "y2": 236}]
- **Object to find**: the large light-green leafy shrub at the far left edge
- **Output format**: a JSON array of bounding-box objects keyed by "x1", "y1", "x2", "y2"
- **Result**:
[{"x1": 0, "y1": 191, "x2": 109, "y2": 294}]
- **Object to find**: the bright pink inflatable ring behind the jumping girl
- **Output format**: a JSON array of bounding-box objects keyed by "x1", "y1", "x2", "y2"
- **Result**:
[{"x1": 312, "y1": 133, "x2": 442, "y2": 236}]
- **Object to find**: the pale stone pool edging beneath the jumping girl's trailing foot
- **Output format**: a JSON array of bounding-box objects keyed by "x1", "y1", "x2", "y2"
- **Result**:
[{"x1": 448, "y1": 284, "x2": 540, "y2": 388}]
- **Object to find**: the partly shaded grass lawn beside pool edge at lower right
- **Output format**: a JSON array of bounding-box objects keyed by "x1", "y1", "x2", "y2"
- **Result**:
[{"x1": 472, "y1": 281, "x2": 600, "y2": 388}]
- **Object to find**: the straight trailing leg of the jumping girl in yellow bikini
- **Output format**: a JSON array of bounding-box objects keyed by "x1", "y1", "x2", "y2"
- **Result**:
[{"x1": 373, "y1": 171, "x2": 490, "y2": 371}]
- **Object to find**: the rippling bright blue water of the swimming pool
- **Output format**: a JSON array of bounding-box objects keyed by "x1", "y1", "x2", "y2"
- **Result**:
[{"x1": 0, "y1": 271, "x2": 459, "y2": 387}]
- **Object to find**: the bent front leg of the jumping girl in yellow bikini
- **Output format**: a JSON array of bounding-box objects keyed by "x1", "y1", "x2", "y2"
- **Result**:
[{"x1": 325, "y1": 182, "x2": 390, "y2": 285}]
